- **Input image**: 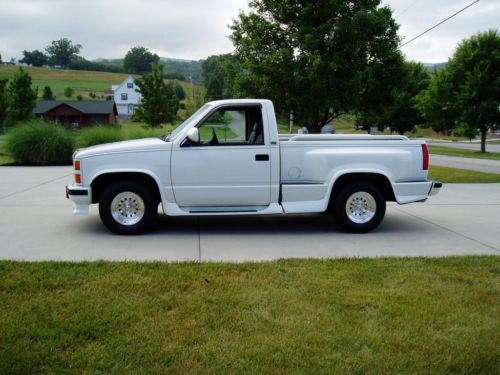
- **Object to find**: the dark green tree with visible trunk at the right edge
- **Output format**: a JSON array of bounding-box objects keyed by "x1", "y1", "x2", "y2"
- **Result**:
[{"x1": 448, "y1": 30, "x2": 500, "y2": 152}]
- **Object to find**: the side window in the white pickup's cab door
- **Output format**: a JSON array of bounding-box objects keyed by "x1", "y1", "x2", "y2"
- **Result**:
[{"x1": 198, "y1": 106, "x2": 264, "y2": 146}]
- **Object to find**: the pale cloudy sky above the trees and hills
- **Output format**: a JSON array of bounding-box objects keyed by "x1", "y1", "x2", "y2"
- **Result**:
[{"x1": 0, "y1": 0, "x2": 500, "y2": 63}]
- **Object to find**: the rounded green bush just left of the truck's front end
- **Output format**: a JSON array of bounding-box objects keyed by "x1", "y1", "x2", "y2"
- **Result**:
[{"x1": 7, "y1": 121, "x2": 74, "y2": 165}]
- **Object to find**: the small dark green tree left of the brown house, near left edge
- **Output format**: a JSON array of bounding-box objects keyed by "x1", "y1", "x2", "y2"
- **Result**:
[{"x1": 9, "y1": 68, "x2": 37, "y2": 121}]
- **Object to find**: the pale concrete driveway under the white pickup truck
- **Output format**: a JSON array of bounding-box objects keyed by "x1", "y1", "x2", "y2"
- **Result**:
[{"x1": 0, "y1": 167, "x2": 500, "y2": 261}]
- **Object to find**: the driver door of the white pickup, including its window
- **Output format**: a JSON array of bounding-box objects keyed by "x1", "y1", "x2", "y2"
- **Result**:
[{"x1": 171, "y1": 105, "x2": 271, "y2": 211}]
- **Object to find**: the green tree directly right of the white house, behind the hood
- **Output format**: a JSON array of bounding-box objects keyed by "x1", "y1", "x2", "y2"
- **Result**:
[{"x1": 132, "y1": 64, "x2": 179, "y2": 127}]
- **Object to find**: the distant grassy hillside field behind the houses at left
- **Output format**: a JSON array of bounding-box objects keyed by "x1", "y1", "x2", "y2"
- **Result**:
[{"x1": 0, "y1": 65, "x2": 191, "y2": 100}]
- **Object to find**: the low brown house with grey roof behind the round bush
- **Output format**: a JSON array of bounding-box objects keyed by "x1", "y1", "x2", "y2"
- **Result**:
[{"x1": 33, "y1": 100, "x2": 118, "y2": 126}]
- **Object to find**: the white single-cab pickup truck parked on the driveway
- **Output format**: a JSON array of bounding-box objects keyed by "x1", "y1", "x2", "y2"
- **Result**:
[{"x1": 66, "y1": 99, "x2": 441, "y2": 234}]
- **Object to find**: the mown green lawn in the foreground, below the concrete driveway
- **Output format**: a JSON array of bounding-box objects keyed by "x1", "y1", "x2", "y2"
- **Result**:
[{"x1": 0, "y1": 257, "x2": 500, "y2": 374}]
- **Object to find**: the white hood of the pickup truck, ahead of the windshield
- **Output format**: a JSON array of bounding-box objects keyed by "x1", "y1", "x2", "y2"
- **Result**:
[{"x1": 74, "y1": 138, "x2": 172, "y2": 159}]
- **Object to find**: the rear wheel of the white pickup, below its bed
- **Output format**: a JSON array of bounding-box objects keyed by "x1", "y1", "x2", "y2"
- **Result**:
[{"x1": 334, "y1": 182, "x2": 385, "y2": 233}]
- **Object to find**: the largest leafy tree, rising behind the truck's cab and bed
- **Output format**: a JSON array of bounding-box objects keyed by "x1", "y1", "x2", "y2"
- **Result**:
[{"x1": 230, "y1": 0, "x2": 402, "y2": 132}]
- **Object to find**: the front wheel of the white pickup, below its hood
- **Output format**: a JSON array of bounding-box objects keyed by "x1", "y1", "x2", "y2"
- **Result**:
[{"x1": 99, "y1": 181, "x2": 158, "y2": 235}]
